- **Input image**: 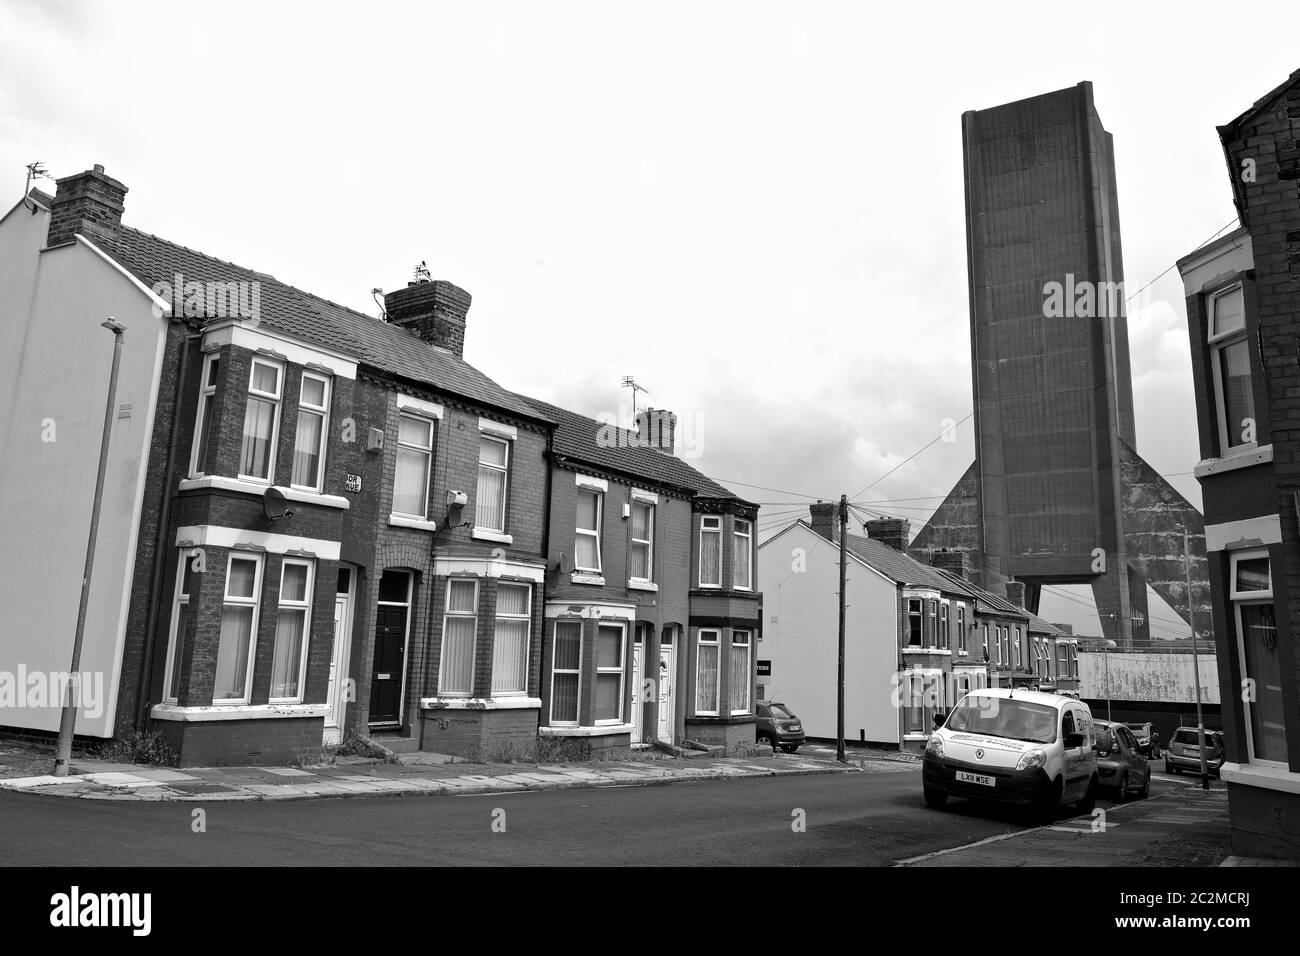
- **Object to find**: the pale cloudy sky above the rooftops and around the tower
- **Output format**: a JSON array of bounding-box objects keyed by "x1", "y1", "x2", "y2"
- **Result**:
[{"x1": 0, "y1": 0, "x2": 1300, "y2": 639}]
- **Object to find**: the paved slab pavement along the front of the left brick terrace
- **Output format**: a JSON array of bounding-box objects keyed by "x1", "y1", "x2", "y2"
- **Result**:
[{"x1": 0, "y1": 741, "x2": 917, "y2": 803}]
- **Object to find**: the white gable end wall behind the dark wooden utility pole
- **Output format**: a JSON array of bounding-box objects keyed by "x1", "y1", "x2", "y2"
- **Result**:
[{"x1": 758, "y1": 524, "x2": 898, "y2": 741}]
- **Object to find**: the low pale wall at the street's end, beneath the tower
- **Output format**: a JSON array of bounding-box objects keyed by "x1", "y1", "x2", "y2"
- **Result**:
[{"x1": 1079, "y1": 650, "x2": 1219, "y2": 704}]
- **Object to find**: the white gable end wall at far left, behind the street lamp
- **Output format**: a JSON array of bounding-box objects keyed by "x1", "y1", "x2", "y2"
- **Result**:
[{"x1": 0, "y1": 206, "x2": 166, "y2": 736}]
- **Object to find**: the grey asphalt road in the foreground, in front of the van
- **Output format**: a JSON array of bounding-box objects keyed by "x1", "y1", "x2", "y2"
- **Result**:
[{"x1": 0, "y1": 770, "x2": 1180, "y2": 866}]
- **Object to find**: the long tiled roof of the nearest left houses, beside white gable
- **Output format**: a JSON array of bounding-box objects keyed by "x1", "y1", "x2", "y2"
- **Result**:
[{"x1": 86, "y1": 226, "x2": 547, "y2": 421}]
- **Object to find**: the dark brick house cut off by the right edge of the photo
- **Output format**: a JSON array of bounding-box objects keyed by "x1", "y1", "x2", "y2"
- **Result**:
[{"x1": 1178, "y1": 72, "x2": 1300, "y2": 858}]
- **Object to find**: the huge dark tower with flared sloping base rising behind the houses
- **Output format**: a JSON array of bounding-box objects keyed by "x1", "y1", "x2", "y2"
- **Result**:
[{"x1": 910, "y1": 82, "x2": 1210, "y2": 646}]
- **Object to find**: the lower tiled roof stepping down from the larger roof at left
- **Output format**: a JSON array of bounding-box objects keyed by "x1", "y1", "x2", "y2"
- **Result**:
[{"x1": 517, "y1": 395, "x2": 751, "y2": 505}]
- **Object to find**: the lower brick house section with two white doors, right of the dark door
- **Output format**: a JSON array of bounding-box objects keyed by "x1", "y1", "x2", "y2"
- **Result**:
[{"x1": 517, "y1": 399, "x2": 762, "y2": 753}]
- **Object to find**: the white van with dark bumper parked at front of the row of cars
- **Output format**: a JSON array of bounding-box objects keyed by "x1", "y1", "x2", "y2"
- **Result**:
[{"x1": 922, "y1": 688, "x2": 1097, "y2": 822}]
